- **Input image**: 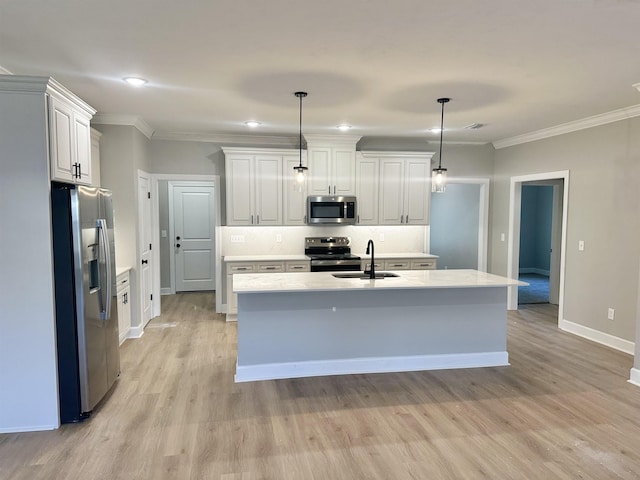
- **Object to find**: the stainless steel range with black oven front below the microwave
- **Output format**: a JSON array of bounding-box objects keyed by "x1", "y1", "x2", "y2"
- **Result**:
[{"x1": 304, "y1": 237, "x2": 360, "y2": 272}]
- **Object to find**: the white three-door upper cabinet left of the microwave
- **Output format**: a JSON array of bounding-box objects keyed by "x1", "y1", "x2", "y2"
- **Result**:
[{"x1": 222, "y1": 147, "x2": 306, "y2": 226}]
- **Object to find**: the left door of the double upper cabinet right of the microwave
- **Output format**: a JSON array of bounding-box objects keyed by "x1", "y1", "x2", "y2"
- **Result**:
[{"x1": 378, "y1": 158, "x2": 404, "y2": 225}]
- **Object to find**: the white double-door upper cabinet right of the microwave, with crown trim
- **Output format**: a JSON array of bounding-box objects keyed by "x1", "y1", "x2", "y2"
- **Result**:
[{"x1": 358, "y1": 152, "x2": 433, "y2": 225}]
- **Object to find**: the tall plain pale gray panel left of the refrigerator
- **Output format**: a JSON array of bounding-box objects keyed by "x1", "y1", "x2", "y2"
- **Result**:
[{"x1": 0, "y1": 85, "x2": 58, "y2": 433}]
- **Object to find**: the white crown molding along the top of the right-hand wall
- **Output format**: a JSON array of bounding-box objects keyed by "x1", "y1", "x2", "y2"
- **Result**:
[{"x1": 493, "y1": 105, "x2": 640, "y2": 150}]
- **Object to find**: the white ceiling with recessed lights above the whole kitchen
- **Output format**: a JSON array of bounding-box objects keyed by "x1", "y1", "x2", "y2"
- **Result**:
[{"x1": 0, "y1": 0, "x2": 640, "y2": 142}]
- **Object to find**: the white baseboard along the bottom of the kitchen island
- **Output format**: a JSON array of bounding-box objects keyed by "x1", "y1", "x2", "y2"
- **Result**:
[{"x1": 235, "y1": 352, "x2": 509, "y2": 383}]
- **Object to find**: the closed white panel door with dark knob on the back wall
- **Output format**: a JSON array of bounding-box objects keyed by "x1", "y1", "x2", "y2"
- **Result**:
[{"x1": 170, "y1": 183, "x2": 216, "y2": 292}]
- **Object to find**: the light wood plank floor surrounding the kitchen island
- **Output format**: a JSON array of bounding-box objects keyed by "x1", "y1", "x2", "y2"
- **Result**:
[{"x1": 0, "y1": 294, "x2": 640, "y2": 480}]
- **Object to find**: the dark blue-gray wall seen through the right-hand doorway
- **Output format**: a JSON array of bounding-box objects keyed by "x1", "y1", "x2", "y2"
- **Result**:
[{"x1": 519, "y1": 185, "x2": 553, "y2": 274}]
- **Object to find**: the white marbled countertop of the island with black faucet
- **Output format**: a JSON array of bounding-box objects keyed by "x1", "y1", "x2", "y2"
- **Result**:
[{"x1": 233, "y1": 270, "x2": 527, "y2": 294}]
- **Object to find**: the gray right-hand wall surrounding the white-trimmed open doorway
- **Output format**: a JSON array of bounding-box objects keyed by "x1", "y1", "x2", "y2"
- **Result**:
[{"x1": 490, "y1": 118, "x2": 640, "y2": 341}]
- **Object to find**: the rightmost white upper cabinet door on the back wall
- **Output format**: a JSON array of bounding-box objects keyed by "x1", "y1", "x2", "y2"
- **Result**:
[{"x1": 404, "y1": 160, "x2": 431, "y2": 225}]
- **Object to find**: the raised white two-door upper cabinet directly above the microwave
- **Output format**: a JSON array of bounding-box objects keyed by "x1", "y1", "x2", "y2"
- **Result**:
[{"x1": 305, "y1": 135, "x2": 362, "y2": 195}]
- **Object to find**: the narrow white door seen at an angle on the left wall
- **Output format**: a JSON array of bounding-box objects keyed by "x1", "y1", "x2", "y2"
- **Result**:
[{"x1": 138, "y1": 172, "x2": 153, "y2": 327}]
